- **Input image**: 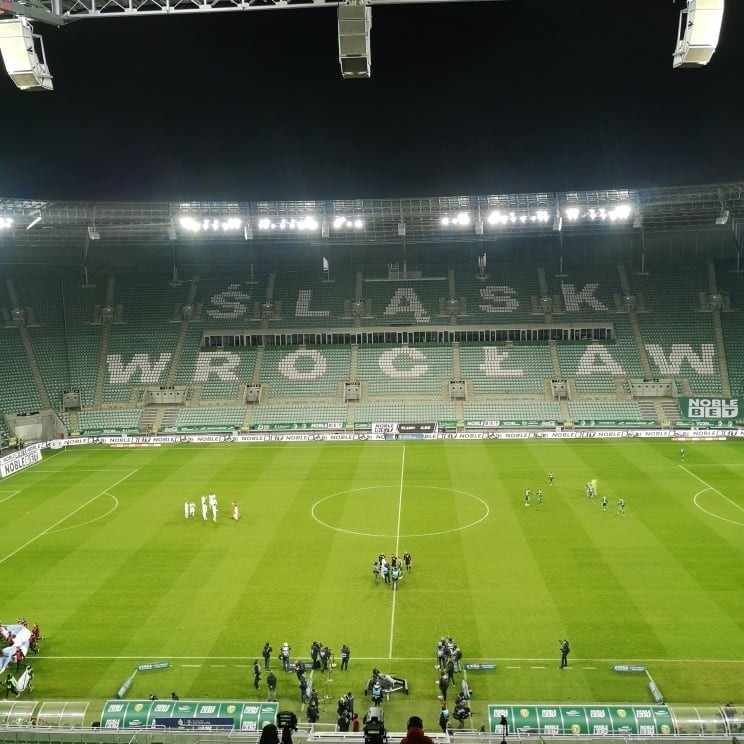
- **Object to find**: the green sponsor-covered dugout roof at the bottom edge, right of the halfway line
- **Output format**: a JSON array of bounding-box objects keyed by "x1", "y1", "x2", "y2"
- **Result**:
[{"x1": 488, "y1": 705, "x2": 675, "y2": 736}]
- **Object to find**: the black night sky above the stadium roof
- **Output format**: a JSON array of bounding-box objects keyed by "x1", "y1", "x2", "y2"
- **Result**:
[{"x1": 0, "y1": 0, "x2": 744, "y2": 200}]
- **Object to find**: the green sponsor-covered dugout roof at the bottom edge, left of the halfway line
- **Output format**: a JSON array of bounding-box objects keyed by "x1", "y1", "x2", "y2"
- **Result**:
[{"x1": 101, "y1": 700, "x2": 278, "y2": 731}]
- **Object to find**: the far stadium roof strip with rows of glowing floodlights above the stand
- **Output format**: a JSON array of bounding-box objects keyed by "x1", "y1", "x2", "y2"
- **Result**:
[{"x1": 0, "y1": 181, "x2": 744, "y2": 249}]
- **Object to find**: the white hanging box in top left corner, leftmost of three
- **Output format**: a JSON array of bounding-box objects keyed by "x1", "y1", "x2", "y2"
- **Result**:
[{"x1": 0, "y1": 16, "x2": 54, "y2": 90}]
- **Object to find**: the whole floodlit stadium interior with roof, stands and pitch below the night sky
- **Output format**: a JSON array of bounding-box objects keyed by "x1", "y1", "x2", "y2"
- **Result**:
[{"x1": 0, "y1": 184, "x2": 744, "y2": 740}]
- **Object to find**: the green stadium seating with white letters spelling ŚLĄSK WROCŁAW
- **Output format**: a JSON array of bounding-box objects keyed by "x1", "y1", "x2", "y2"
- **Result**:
[{"x1": 0, "y1": 251, "x2": 744, "y2": 438}]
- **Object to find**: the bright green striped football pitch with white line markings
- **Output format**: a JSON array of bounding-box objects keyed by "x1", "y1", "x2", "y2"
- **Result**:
[{"x1": 0, "y1": 439, "x2": 744, "y2": 730}]
